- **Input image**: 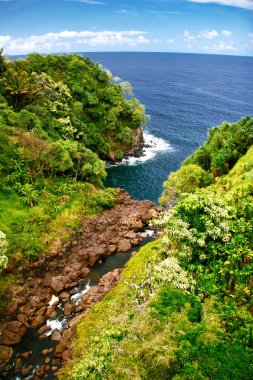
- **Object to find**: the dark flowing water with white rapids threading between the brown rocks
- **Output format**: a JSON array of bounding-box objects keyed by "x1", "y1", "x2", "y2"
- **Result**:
[{"x1": 6, "y1": 229, "x2": 154, "y2": 380}]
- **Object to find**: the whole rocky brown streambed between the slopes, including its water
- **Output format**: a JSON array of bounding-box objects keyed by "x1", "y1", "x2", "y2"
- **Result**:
[{"x1": 0, "y1": 192, "x2": 161, "y2": 379}]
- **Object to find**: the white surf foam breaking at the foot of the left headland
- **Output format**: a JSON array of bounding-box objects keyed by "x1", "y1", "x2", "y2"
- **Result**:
[{"x1": 114, "y1": 132, "x2": 173, "y2": 165}]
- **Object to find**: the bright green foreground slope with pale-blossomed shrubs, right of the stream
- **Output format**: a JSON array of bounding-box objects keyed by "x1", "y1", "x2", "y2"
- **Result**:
[{"x1": 59, "y1": 118, "x2": 253, "y2": 380}]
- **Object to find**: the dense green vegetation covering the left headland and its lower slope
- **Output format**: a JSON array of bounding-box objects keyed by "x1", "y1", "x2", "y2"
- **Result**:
[{"x1": 0, "y1": 50, "x2": 145, "y2": 290}]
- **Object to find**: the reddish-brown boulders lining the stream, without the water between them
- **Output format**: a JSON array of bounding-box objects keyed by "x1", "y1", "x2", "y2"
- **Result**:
[{"x1": 0, "y1": 192, "x2": 161, "y2": 379}]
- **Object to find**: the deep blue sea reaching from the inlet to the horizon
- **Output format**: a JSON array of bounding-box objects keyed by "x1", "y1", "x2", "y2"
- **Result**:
[{"x1": 85, "y1": 53, "x2": 253, "y2": 202}]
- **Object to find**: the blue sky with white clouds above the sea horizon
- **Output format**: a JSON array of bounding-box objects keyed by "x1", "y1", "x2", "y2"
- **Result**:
[{"x1": 0, "y1": 0, "x2": 253, "y2": 56}]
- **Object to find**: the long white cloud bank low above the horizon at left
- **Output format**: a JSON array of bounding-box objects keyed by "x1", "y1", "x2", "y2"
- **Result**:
[{"x1": 0, "y1": 30, "x2": 150, "y2": 54}]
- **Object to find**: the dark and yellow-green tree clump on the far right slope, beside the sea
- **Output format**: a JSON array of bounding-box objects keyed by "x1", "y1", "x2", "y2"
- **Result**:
[{"x1": 160, "y1": 116, "x2": 253, "y2": 205}]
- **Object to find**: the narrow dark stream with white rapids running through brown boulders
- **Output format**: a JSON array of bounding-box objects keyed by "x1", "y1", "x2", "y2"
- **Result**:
[{"x1": 4, "y1": 229, "x2": 154, "y2": 380}]
